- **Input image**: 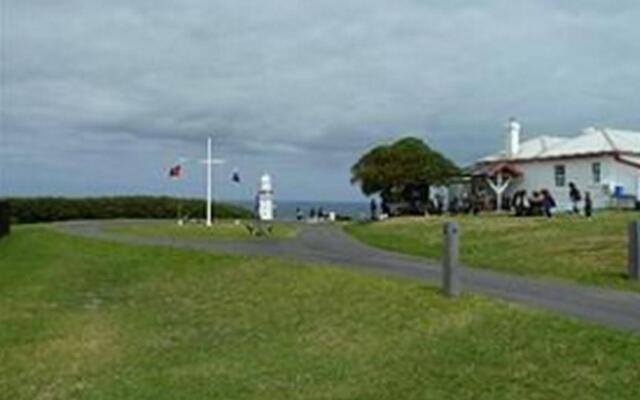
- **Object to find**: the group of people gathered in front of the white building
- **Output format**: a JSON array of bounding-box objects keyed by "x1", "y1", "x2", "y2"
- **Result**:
[{"x1": 511, "y1": 182, "x2": 593, "y2": 218}]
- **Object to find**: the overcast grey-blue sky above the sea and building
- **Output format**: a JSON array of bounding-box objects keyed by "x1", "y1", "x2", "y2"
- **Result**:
[{"x1": 0, "y1": 0, "x2": 640, "y2": 200}]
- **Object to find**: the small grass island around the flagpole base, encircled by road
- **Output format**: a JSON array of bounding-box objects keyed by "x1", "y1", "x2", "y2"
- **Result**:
[{"x1": 105, "y1": 220, "x2": 298, "y2": 240}]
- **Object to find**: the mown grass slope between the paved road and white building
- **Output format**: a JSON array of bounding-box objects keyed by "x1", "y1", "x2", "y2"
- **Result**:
[{"x1": 345, "y1": 211, "x2": 640, "y2": 291}]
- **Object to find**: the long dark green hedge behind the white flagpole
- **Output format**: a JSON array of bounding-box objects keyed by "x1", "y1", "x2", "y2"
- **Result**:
[{"x1": 7, "y1": 196, "x2": 251, "y2": 223}]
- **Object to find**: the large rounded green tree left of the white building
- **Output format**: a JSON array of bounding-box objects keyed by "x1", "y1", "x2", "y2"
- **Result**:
[{"x1": 351, "y1": 137, "x2": 460, "y2": 205}]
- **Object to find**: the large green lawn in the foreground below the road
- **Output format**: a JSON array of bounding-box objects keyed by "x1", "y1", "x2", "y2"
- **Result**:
[{"x1": 0, "y1": 227, "x2": 640, "y2": 400}]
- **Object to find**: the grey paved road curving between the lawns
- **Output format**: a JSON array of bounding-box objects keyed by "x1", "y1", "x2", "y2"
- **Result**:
[{"x1": 57, "y1": 221, "x2": 640, "y2": 332}]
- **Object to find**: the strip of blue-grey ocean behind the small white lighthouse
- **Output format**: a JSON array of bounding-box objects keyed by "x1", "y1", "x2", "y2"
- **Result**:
[{"x1": 233, "y1": 200, "x2": 369, "y2": 221}]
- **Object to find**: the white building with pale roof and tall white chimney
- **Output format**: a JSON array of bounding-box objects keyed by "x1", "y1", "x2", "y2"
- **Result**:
[{"x1": 474, "y1": 119, "x2": 640, "y2": 210}]
